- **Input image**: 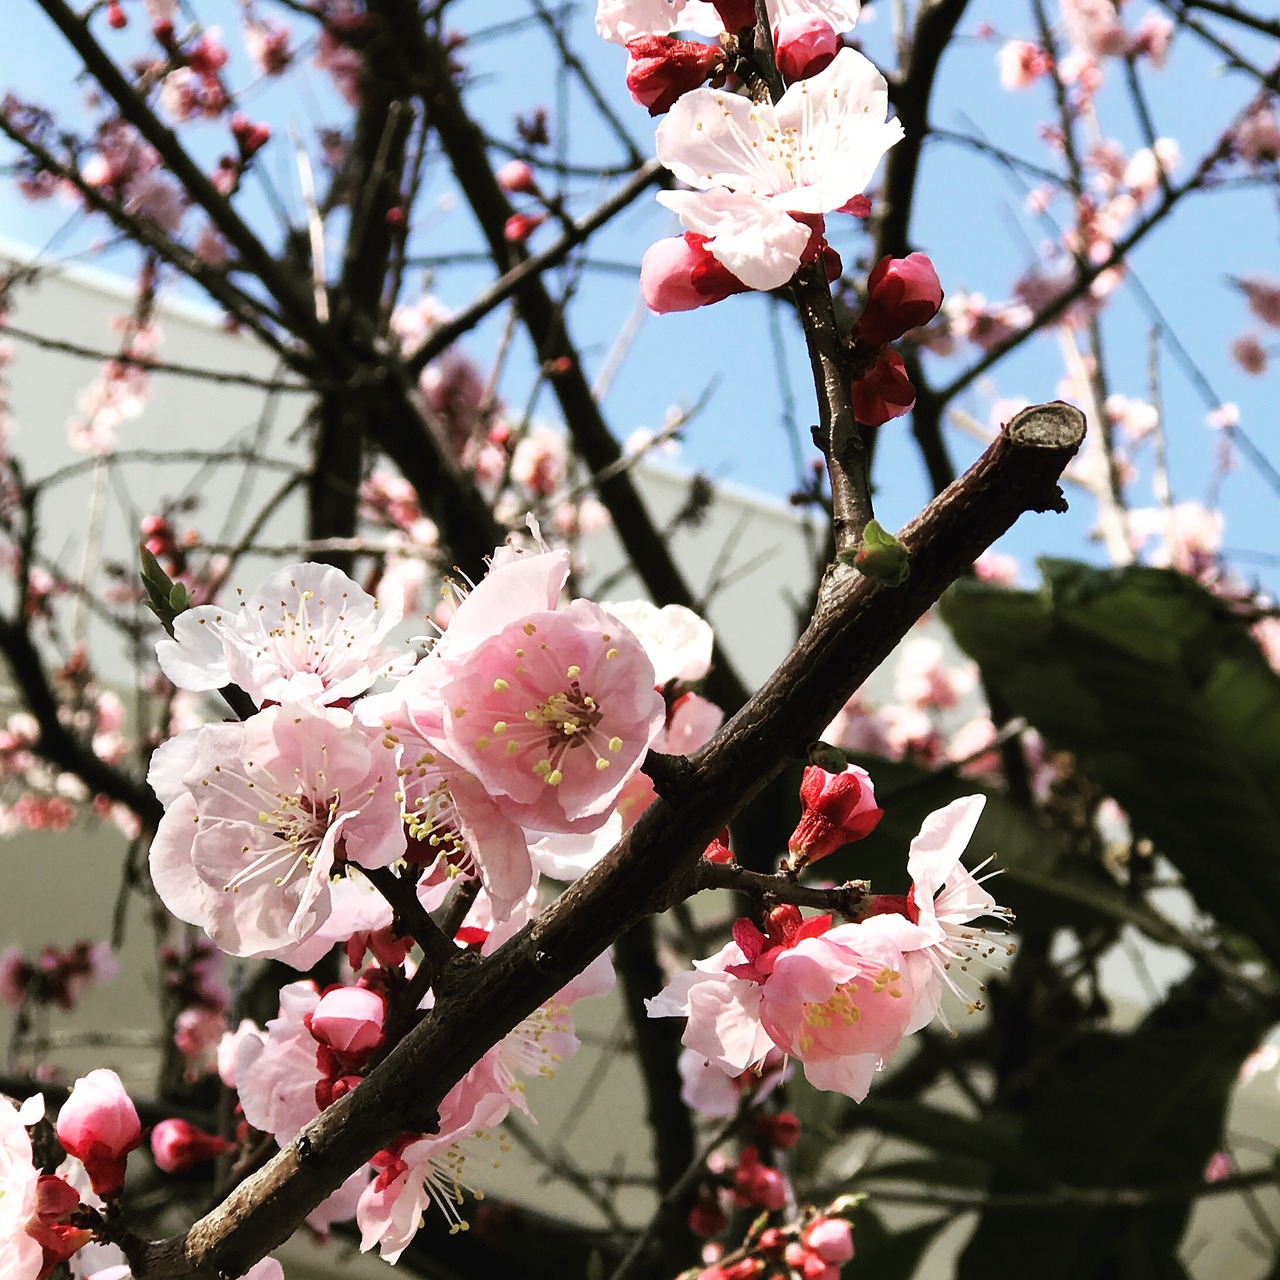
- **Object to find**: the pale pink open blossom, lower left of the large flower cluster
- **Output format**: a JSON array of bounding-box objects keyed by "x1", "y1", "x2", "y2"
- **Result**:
[{"x1": 148, "y1": 707, "x2": 404, "y2": 956}]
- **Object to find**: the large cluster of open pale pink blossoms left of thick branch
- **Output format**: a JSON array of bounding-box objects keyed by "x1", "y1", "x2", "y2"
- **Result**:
[{"x1": 150, "y1": 547, "x2": 666, "y2": 956}]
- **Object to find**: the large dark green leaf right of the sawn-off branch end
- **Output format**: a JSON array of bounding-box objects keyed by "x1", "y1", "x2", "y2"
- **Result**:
[{"x1": 943, "y1": 561, "x2": 1280, "y2": 964}]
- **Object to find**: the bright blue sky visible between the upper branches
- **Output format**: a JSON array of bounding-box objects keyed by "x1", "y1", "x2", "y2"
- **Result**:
[{"x1": 0, "y1": 0, "x2": 1280, "y2": 586}]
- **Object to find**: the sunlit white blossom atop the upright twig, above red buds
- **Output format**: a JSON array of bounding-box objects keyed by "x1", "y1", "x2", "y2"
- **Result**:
[{"x1": 657, "y1": 49, "x2": 902, "y2": 289}]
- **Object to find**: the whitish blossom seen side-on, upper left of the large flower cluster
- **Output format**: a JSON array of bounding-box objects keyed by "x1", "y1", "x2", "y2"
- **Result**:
[{"x1": 156, "y1": 563, "x2": 413, "y2": 705}]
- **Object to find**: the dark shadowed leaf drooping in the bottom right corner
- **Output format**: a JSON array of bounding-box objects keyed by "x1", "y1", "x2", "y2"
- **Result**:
[{"x1": 956, "y1": 973, "x2": 1271, "y2": 1280}]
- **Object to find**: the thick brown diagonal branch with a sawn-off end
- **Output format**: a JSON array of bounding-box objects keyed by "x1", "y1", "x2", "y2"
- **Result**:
[{"x1": 128, "y1": 404, "x2": 1084, "y2": 1280}]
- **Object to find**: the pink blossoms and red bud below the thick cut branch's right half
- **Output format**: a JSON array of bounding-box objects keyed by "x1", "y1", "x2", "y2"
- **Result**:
[{"x1": 648, "y1": 793, "x2": 1006, "y2": 1101}]
